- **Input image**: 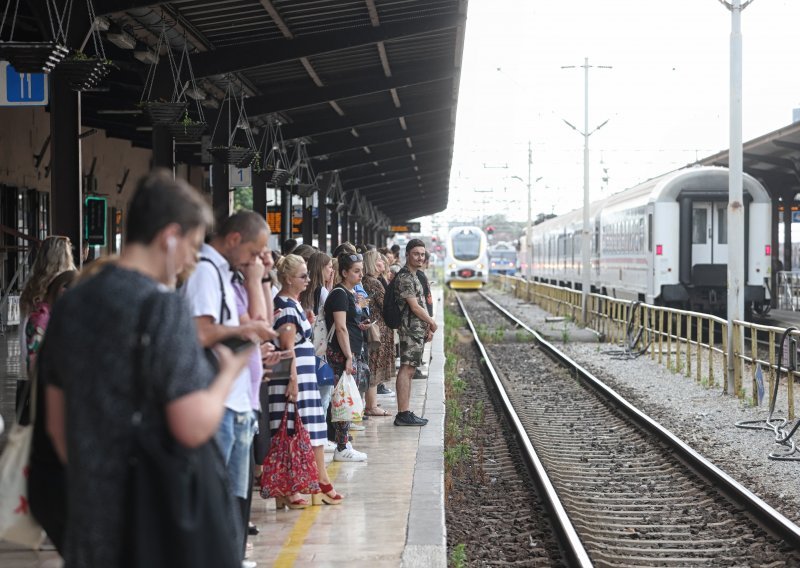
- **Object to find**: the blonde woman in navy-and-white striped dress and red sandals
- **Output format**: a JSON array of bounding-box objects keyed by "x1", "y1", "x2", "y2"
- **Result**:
[{"x1": 268, "y1": 254, "x2": 343, "y2": 509}]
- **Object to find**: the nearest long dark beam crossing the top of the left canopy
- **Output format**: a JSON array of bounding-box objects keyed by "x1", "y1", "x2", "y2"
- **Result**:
[{"x1": 172, "y1": 14, "x2": 465, "y2": 78}]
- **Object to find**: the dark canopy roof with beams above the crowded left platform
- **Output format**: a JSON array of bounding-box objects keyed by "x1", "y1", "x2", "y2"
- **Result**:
[{"x1": 12, "y1": 0, "x2": 467, "y2": 223}]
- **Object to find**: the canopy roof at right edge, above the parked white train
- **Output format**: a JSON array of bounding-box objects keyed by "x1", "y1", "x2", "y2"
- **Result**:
[{"x1": 699, "y1": 122, "x2": 800, "y2": 200}]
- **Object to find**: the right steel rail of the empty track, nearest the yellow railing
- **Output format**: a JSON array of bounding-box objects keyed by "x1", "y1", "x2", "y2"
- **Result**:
[{"x1": 476, "y1": 292, "x2": 800, "y2": 549}]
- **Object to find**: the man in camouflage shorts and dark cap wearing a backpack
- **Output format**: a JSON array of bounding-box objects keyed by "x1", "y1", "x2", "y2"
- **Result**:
[{"x1": 394, "y1": 239, "x2": 436, "y2": 426}]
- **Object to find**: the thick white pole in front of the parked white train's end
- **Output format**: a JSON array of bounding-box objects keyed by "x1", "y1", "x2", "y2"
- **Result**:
[{"x1": 720, "y1": 0, "x2": 753, "y2": 394}]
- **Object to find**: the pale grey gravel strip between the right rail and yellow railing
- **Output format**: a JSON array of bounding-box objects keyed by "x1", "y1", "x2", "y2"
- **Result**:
[{"x1": 487, "y1": 289, "x2": 800, "y2": 523}]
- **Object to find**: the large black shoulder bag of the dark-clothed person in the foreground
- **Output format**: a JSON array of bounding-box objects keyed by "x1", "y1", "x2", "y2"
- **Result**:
[{"x1": 120, "y1": 292, "x2": 241, "y2": 568}]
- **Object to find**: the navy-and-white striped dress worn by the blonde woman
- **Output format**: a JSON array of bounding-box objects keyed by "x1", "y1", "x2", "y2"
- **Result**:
[{"x1": 267, "y1": 295, "x2": 328, "y2": 446}]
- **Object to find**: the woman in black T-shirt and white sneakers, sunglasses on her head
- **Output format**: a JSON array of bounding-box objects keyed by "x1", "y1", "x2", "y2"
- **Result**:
[{"x1": 325, "y1": 252, "x2": 369, "y2": 462}]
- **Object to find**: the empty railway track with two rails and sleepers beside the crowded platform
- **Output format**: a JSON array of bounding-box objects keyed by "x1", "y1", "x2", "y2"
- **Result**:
[{"x1": 458, "y1": 294, "x2": 800, "y2": 566}]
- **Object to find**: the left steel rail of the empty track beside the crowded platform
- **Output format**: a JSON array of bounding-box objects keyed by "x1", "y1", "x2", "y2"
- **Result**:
[{"x1": 456, "y1": 294, "x2": 593, "y2": 568}]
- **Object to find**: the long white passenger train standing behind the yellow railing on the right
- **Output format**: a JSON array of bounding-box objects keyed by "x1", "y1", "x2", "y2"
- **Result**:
[{"x1": 519, "y1": 167, "x2": 771, "y2": 313}]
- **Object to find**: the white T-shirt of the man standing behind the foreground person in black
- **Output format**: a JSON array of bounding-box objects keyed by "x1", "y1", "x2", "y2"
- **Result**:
[{"x1": 183, "y1": 244, "x2": 253, "y2": 412}]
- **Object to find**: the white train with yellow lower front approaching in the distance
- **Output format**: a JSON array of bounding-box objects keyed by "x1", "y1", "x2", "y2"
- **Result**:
[{"x1": 444, "y1": 227, "x2": 489, "y2": 289}]
